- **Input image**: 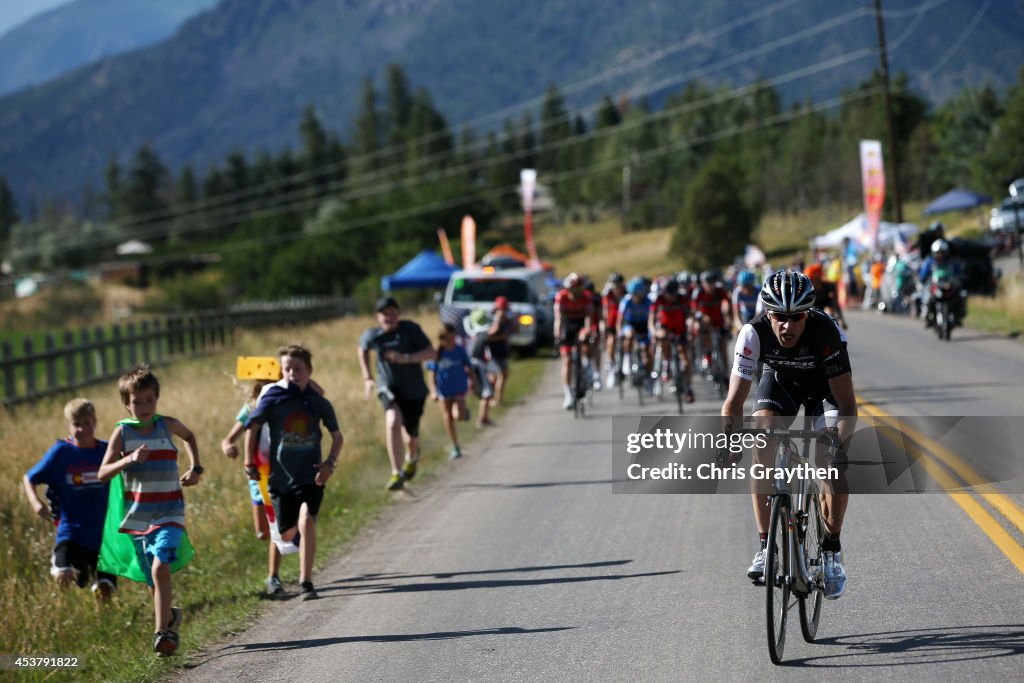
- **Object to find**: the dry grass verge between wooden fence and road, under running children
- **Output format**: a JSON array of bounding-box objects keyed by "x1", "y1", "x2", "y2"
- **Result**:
[{"x1": 0, "y1": 316, "x2": 544, "y2": 682}]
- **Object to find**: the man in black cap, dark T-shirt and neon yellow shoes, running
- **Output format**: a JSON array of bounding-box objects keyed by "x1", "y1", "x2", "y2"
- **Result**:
[{"x1": 358, "y1": 297, "x2": 436, "y2": 490}]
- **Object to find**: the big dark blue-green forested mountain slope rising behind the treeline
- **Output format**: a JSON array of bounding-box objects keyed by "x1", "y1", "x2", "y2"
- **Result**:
[{"x1": 0, "y1": 0, "x2": 1024, "y2": 206}]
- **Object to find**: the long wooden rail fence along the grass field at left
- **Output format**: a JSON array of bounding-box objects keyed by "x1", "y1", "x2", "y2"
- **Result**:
[{"x1": 0, "y1": 298, "x2": 355, "y2": 405}]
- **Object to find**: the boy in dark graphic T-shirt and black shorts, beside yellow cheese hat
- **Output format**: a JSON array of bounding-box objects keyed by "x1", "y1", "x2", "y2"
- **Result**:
[{"x1": 245, "y1": 346, "x2": 343, "y2": 600}]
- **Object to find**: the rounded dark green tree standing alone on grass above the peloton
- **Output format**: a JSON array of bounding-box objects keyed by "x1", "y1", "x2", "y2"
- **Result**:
[{"x1": 671, "y1": 153, "x2": 754, "y2": 270}]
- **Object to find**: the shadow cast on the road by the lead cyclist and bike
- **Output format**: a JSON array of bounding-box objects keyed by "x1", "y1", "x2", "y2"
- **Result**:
[{"x1": 783, "y1": 624, "x2": 1024, "y2": 667}]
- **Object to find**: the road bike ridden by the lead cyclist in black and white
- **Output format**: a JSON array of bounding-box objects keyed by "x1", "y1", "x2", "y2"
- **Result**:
[{"x1": 743, "y1": 428, "x2": 840, "y2": 665}]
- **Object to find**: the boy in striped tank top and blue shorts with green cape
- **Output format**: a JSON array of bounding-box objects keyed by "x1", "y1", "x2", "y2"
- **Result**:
[{"x1": 99, "y1": 366, "x2": 203, "y2": 656}]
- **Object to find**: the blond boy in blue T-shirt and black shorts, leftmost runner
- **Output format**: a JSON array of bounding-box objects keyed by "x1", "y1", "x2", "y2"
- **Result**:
[{"x1": 22, "y1": 398, "x2": 117, "y2": 602}]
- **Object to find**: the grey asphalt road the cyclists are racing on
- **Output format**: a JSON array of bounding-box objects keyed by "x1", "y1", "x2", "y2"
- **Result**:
[{"x1": 183, "y1": 313, "x2": 1024, "y2": 682}]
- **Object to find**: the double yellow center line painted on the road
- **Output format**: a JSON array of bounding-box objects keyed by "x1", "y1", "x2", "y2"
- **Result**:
[{"x1": 857, "y1": 399, "x2": 1024, "y2": 573}]
